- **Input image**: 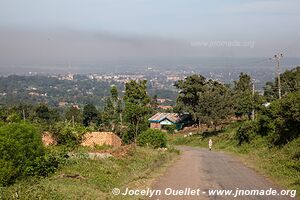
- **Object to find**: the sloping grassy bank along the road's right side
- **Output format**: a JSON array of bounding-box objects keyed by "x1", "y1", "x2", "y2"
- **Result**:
[{"x1": 169, "y1": 122, "x2": 300, "y2": 198}]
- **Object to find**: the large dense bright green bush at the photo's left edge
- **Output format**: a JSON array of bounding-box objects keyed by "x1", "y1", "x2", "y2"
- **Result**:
[{"x1": 0, "y1": 123, "x2": 44, "y2": 185}]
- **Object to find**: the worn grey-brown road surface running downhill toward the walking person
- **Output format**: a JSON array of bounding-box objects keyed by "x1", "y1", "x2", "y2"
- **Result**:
[{"x1": 150, "y1": 147, "x2": 296, "y2": 200}]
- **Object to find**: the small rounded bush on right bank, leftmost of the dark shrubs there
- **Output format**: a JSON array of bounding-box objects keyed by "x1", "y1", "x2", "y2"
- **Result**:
[{"x1": 235, "y1": 121, "x2": 257, "y2": 145}]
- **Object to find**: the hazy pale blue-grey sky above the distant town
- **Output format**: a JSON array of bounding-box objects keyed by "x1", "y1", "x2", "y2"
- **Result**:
[{"x1": 0, "y1": 0, "x2": 300, "y2": 66}]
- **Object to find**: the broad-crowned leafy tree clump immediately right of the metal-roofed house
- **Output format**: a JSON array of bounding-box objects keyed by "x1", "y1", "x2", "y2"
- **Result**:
[{"x1": 175, "y1": 75, "x2": 233, "y2": 127}]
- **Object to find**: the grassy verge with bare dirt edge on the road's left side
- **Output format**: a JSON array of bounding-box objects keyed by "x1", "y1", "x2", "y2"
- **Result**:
[{"x1": 0, "y1": 147, "x2": 179, "y2": 200}]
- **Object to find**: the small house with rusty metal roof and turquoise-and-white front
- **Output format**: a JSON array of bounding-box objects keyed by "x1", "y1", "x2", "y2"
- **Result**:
[{"x1": 148, "y1": 113, "x2": 189, "y2": 130}]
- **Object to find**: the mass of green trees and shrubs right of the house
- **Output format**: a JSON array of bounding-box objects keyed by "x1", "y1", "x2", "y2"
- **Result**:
[{"x1": 175, "y1": 67, "x2": 300, "y2": 146}]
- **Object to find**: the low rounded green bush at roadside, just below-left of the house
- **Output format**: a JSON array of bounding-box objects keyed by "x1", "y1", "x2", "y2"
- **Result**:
[{"x1": 137, "y1": 129, "x2": 167, "y2": 148}]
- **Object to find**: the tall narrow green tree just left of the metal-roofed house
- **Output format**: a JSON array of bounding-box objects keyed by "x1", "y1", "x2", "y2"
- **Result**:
[{"x1": 123, "y1": 80, "x2": 150, "y2": 143}]
